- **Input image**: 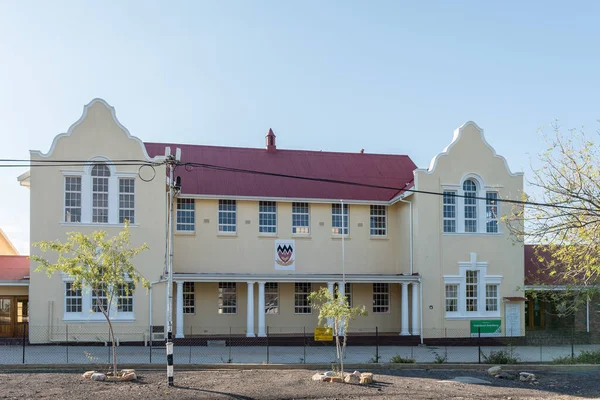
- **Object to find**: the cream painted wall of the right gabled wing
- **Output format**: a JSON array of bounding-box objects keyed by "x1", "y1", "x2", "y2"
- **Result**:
[{"x1": 412, "y1": 124, "x2": 524, "y2": 336}]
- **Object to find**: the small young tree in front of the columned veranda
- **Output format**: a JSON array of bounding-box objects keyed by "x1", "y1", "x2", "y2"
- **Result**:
[{"x1": 308, "y1": 287, "x2": 367, "y2": 379}]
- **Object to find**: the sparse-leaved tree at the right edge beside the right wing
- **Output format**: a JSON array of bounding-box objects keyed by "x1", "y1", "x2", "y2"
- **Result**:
[{"x1": 508, "y1": 124, "x2": 600, "y2": 314}]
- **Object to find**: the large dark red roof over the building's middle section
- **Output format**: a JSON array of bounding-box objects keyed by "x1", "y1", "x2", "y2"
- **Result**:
[{"x1": 145, "y1": 143, "x2": 416, "y2": 201}]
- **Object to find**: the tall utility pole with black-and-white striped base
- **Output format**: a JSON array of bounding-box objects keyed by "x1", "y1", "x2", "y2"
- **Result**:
[{"x1": 165, "y1": 147, "x2": 181, "y2": 386}]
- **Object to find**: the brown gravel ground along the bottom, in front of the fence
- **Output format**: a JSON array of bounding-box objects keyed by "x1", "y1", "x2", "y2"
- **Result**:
[{"x1": 0, "y1": 369, "x2": 600, "y2": 400}]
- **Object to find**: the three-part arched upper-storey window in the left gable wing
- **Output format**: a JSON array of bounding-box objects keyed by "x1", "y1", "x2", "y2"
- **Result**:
[{"x1": 63, "y1": 158, "x2": 137, "y2": 224}]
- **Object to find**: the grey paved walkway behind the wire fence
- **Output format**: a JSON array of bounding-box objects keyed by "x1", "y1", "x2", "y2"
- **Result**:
[{"x1": 0, "y1": 345, "x2": 600, "y2": 365}]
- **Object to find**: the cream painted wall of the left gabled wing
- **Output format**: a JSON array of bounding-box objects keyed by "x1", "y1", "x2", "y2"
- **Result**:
[{"x1": 29, "y1": 101, "x2": 166, "y2": 342}]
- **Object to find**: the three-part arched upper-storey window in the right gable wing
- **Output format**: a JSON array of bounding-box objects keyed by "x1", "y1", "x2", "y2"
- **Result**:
[{"x1": 442, "y1": 177, "x2": 500, "y2": 233}]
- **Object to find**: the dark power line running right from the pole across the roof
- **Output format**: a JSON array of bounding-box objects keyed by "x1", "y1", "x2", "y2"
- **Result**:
[{"x1": 180, "y1": 162, "x2": 590, "y2": 211}]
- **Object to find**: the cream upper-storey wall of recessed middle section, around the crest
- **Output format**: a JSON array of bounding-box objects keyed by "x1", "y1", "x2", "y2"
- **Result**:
[{"x1": 174, "y1": 200, "x2": 410, "y2": 275}]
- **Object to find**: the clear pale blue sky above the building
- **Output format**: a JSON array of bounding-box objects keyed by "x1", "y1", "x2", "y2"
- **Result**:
[{"x1": 0, "y1": 0, "x2": 600, "y2": 254}]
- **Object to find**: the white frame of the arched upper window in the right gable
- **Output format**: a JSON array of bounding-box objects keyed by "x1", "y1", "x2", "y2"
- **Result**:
[{"x1": 440, "y1": 174, "x2": 503, "y2": 235}]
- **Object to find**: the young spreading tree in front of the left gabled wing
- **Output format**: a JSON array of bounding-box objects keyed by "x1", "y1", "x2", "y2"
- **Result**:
[{"x1": 31, "y1": 222, "x2": 149, "y2": 376}]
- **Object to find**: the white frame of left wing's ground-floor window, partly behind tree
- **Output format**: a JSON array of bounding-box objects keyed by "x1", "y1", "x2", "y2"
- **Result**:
[{"x1": 61, "y1": 273, "x2": 135, "y2": 322}]
